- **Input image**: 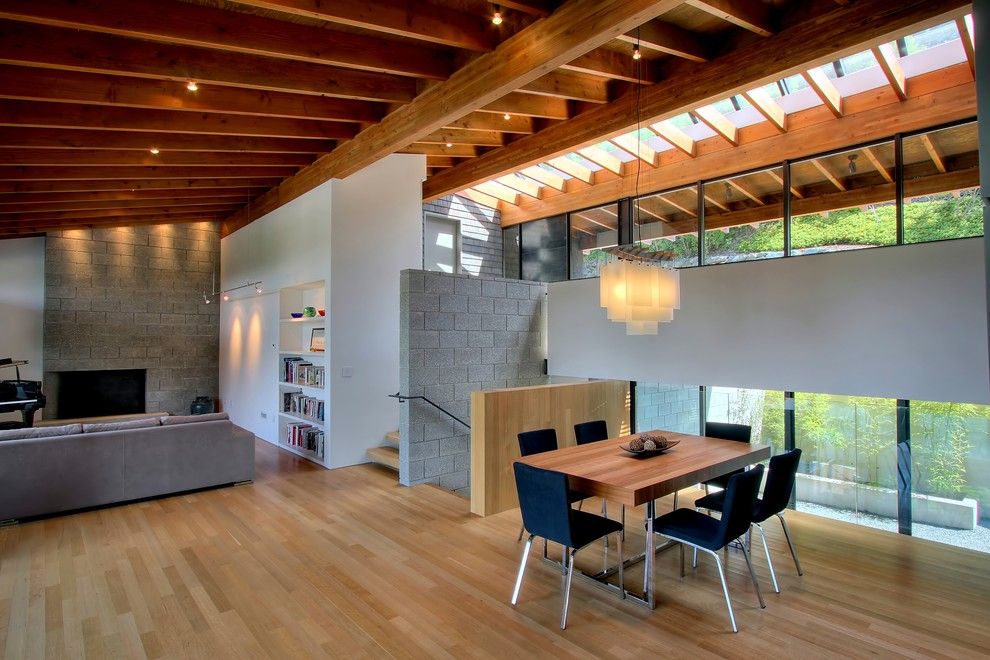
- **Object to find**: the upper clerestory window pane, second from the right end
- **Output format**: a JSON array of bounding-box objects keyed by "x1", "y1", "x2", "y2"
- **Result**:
[{"x1": 791, "y1": 142, "x2": 897, "y2": 254}]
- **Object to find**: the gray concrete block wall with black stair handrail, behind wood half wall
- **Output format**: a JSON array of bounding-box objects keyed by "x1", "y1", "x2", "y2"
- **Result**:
[{"x1": 399, "y1": 270, "x2": 549, "y2": 496}]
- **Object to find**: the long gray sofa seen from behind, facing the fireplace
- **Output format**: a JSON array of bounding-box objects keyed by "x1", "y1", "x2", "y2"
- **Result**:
[{"x1": 0, "y1": 413, "x2": 254, "y2": 521}]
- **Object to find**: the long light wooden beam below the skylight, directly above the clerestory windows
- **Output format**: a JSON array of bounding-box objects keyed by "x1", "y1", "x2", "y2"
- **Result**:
[{"x1": 500, "y1": 68, "x2": 976, "y2": 226}]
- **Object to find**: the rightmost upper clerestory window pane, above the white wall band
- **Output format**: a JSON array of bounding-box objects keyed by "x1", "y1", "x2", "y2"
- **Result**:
[{"x1": 904, "y1": 122, "x2": 983, "y2": 243}]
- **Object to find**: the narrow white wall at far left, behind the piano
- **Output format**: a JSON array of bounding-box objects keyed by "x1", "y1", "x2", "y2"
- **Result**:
[{"x1": 0, "y1": 237, "x2": 45, "y2": 420}]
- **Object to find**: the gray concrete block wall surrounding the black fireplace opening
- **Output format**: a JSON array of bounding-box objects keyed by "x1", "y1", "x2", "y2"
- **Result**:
[{"x1": 44, "y1": 222, "x2": 220, "y2": 418}]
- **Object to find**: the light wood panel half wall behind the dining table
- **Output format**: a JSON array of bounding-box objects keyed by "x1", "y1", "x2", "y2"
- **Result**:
[{"x1": 471, "y1": 380, "x2": 630, "y2": 516}]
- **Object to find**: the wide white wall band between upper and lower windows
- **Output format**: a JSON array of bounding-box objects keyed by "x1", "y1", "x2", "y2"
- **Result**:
[{"x1": 548, "y1": 238, "x2": 990, "y2": 404}]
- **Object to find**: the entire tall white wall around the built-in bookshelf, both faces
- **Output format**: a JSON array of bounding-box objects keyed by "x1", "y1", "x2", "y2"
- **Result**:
[{"x1": 220, "y1": 155, "x2": 426, "y2": 467}]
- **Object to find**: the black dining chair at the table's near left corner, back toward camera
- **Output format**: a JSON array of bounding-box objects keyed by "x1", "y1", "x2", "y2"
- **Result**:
[{"x1": 512, "y1": 462, "x2": 626, "y2": 630}]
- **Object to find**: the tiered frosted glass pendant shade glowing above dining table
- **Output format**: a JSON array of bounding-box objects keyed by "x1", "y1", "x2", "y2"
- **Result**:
[{"x1": 599, "y1": 260, "x2": 681, "y2": 335}]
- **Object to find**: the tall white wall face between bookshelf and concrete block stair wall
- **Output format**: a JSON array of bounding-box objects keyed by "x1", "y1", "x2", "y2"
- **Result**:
[{"x1": 328, "y1": 154, "x2": 426, "y2": 467}]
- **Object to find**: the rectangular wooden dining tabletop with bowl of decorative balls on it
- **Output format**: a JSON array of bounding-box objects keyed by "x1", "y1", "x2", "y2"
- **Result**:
[{"x1": 519, "y1": 431, "x2": 770, "y2": 506}]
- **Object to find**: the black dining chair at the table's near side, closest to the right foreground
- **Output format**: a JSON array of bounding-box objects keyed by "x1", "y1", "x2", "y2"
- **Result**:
[{"x1": 653, "y1": 465, "x2": 767, "y2": 632}]
